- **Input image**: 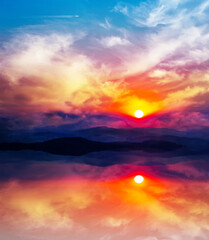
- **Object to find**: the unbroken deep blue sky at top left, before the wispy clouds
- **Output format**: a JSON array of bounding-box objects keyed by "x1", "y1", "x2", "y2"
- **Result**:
[{"x1": 0, "y1": 0, "x2": 118, "y2": 29}]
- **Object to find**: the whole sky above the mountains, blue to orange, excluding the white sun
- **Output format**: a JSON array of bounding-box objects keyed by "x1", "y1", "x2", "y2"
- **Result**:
[{"x1": 0, "y1": 0, "x2": 209, "y2": 130}]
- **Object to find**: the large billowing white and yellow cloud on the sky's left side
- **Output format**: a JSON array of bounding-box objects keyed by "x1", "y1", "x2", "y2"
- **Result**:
[{"x1": 0, "y1": 33, "x2": 122, "y2": 124}]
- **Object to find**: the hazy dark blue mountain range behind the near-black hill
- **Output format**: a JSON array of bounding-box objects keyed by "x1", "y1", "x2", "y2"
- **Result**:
[{"x1": 0, "y1": 125, "x2": 209, "y2": 143}]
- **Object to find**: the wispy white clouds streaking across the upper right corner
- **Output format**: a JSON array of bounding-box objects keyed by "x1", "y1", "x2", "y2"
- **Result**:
[{"x1": 115, "y1": 1, "x2": 208, "y2": 74}]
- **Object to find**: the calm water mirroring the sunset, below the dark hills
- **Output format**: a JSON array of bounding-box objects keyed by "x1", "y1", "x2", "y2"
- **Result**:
[{"x1": 0, "y1": 151, "x2": 209, "y2": 240}]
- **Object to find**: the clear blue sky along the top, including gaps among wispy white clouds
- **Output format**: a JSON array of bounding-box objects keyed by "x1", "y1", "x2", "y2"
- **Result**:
[{"x1": 0, "y1": 0, "x2": 205, "y2": 32}]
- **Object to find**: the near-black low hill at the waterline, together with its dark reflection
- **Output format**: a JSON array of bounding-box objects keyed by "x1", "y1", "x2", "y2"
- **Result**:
[{"x1": 0, "y1": 137, "x2": 182, "y2": 156}]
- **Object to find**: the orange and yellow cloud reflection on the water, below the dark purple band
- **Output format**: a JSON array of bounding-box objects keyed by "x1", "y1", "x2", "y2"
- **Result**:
[{"x1": 0, "y1": 165, "x2": 209, "y2": 240}]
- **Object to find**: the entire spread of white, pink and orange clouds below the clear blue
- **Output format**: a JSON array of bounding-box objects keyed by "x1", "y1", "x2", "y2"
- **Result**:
[{"x1": 0, "y1": 0, "x2": 209, "y2": 130}]
